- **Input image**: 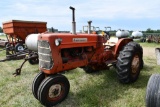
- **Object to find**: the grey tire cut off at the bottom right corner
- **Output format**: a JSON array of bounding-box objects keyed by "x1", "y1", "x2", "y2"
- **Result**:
[{"x1": 146, "y1": 74, "x2": 160, "y2": 107}]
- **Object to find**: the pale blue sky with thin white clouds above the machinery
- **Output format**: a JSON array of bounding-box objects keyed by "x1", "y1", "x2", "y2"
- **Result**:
[{"x1": 0, "y1": 0, "x2": 160, "y2": 31}]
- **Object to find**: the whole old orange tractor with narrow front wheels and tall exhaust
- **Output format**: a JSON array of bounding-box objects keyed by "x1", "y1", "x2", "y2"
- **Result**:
[{"x1": 29, "y1": 7, "x2": 143, "y2": 106}]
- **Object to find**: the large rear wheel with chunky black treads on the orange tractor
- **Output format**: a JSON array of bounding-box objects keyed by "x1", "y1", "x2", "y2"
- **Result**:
[{"x1": 116, "y1": 42, "x2": 143, "y2": 83}]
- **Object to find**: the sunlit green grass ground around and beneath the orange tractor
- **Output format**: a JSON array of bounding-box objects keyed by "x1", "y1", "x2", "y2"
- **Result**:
[{"x1": 0, "y1": 43, "x2": 160, "y2": 107}]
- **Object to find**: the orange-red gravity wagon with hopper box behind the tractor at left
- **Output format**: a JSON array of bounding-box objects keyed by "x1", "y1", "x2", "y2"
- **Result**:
[{"x1": 0, "y1": 20, "x2": 47, "y2": 61}]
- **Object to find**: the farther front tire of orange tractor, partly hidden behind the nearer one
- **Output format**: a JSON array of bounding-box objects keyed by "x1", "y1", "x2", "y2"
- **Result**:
[{"x1": 32, "y1": 72, "x2": 45, "y2": 99}]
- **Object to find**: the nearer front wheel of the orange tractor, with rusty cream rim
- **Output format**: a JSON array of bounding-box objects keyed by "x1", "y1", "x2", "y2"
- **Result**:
[{"x1": 38, "y1": 74, "x2": 70, "y2": 107}]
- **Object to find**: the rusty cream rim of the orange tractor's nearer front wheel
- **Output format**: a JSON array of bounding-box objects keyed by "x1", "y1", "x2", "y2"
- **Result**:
[{"x1": 48, "y1": 84, "x2": 64, "y2": 101}]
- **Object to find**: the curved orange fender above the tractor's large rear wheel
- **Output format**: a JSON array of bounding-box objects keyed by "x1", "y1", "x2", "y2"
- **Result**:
[{"x1": 114, "y1": 38, "x2": 133, "y2": 59}]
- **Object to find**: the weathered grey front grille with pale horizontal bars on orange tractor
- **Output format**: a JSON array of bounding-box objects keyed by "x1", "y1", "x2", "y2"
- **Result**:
[{"x1": 38, "y1": 41, "x2": 54, "y2": 70}]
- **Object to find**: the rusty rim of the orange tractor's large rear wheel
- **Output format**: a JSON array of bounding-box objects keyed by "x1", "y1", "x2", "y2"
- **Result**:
[{"x1": 131, "y1": 55, "x2": 140, "y2": 74}]
